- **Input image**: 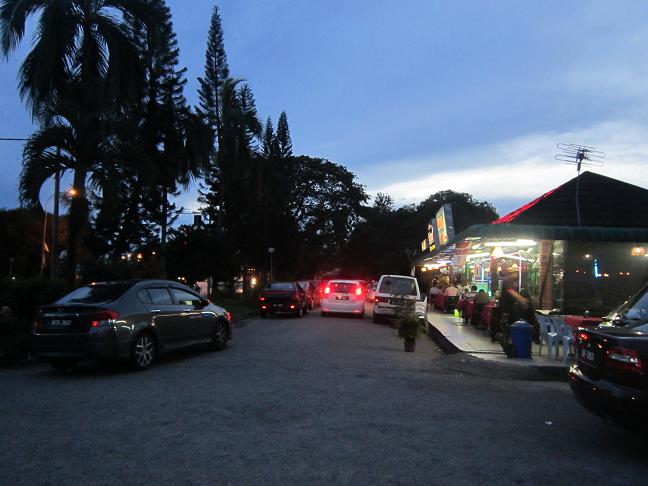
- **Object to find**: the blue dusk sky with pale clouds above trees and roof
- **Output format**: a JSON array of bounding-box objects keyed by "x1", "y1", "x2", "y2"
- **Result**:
[{"x1": 0, "y1": 0, "x2": 648, "y2": 222}]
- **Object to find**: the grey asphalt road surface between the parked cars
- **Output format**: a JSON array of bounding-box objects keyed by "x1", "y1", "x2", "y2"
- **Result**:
[{"x1": 0, "y1": 313, "x2": 648, "y2": 485}]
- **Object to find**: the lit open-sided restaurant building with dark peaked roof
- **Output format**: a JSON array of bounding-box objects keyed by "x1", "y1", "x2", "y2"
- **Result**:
[{"x1": 413, "y1": 172, "x2": 648, "y2": 315}]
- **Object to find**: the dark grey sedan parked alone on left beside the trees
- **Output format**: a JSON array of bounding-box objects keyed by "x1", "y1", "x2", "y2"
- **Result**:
[{"x1": 33, "y1": 280, "x2": 232, "y2": 371}]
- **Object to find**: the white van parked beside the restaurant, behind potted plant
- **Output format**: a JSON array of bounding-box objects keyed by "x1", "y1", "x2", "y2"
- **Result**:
[{"x1": 373, "y1": 275, "x2": 427, "y2": 325}]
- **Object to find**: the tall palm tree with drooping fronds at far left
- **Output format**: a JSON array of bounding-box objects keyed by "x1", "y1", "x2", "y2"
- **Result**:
[{"x1": 0, "y1": 0, "x2": 162, "y2": 275}]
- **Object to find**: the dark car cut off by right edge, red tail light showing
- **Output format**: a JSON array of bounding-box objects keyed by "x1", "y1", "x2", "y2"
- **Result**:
[{"x1": 569, "y1": 285, "x2": 648, "y2": 430}]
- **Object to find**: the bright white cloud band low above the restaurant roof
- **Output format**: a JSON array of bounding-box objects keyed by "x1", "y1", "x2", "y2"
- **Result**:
[{"x1": 359, "y1": 121, "x2": 648, "y2": 211}]
